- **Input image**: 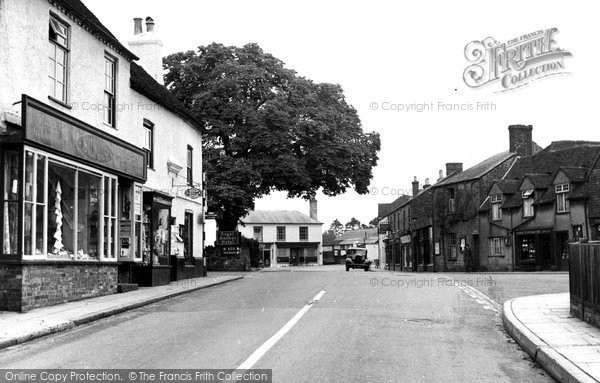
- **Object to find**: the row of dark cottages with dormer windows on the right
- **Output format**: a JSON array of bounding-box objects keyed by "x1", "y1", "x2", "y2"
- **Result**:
[{"x1": 380, "y1": 125, "x2": 600, "y2": 271}]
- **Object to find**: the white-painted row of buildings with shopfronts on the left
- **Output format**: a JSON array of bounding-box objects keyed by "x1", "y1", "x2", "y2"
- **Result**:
[{"x1": 0, "y1": 0, "x2": 205, "y2": 311}]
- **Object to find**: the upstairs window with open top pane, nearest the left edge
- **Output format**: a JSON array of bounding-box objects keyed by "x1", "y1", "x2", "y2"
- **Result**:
[{"x1": 48, "y1": 15, "x2": 69, "y2": 103}]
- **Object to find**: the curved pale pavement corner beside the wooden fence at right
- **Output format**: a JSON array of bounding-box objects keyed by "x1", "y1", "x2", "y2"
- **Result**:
[{"x1": 503, "y1": 293, "x2": 600, "y2": 382}]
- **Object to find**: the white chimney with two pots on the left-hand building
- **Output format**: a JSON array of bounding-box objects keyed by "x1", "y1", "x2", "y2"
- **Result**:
[{"x1": 129, "y1": 17, "x2": 164, "y2": 85}]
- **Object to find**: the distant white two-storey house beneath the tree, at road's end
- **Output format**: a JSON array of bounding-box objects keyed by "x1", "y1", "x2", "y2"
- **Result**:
[{"x1": 238, "y1": 200, "x2": 323, "y2": 267}]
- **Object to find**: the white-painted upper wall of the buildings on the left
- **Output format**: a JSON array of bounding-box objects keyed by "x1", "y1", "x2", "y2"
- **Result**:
[{"x1": 0, "y1": 0, "x2": 203, "y2": 257}]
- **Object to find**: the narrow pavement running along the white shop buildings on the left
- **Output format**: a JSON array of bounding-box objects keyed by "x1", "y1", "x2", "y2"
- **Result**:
[{"x1": 0, "y1": 273, "x2": 243, "y2": 349}]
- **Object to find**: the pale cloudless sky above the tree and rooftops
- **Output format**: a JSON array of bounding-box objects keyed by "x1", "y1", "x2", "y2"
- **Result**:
[{"x1": 84, "y1": 0, "x2": 600, "y2": 229}]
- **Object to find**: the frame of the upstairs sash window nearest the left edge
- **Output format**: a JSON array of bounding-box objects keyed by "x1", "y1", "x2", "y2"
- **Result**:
[{"x1": 48, "y1": 12, "x2": 71, "y2": 107}]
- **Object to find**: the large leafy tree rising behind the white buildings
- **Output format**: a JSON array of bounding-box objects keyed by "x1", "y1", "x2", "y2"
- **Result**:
[{"x1": 164, "y1": 43, "x2": 380, "y2": 230}]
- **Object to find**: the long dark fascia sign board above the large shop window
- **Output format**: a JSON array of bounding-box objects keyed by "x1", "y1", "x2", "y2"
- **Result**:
[{"x1": 22, "y1": 96, "x2": 146, "y2": 181}]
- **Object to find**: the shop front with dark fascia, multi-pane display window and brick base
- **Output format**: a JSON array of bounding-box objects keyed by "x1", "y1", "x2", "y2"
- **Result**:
[{"x1": 0, "y1": 96, "x2": 146, "y2": 311}]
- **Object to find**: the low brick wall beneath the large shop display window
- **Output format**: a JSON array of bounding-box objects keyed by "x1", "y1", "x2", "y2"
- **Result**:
[{"x1": 0, "y1": 262, "x2": 118, "y2": 311}]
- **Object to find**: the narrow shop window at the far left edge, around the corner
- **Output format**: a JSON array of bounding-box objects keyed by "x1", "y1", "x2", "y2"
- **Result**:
[{"x1": 2, "y1": 150, "x2": 21, "y2": 254}]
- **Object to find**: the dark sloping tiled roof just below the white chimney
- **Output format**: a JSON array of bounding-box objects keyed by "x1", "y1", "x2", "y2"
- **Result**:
[{"x1": 130, "y1": 62, "x2": 201, "y2": 129}]
